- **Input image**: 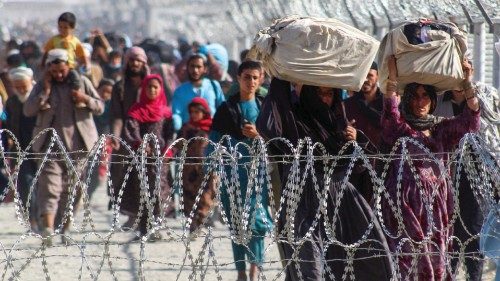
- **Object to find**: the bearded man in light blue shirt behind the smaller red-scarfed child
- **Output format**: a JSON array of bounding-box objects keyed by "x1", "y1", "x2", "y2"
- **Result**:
[{"x1": 172, "y1": 54, "x2": 225, "y2": 131}]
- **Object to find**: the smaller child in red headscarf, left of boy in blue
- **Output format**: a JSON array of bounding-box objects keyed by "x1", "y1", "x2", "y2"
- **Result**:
[{"x1": 178, "y1": 97, "x2": 215, "y2": 232}]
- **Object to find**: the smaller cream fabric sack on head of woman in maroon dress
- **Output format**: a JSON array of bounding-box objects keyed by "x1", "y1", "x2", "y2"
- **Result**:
[{"x1": 379, "y1": 21, "x2": 467, "y2": 93}]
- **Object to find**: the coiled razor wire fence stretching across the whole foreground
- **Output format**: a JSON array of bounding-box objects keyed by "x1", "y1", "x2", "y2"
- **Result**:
[{"x1": 0, "y1": 129, "x2": 500, "y2": 280}]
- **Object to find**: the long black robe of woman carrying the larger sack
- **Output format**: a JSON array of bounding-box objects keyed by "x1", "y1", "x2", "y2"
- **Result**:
[{"x1": 257, "y1": 78, "x2": 392, "y2": 280}]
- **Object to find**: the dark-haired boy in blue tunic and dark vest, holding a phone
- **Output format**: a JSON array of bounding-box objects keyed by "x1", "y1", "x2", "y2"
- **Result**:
[{"x1": 206, "y1": 60, "x2": 272, "y2": 280}]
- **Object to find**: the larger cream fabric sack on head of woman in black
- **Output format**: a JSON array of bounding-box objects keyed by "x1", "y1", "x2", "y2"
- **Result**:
[{"x1": 249, "y1": 16, "x2": 380, "y2": 91}]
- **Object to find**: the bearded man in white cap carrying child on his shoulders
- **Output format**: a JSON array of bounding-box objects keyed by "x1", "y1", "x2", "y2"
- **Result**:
[{"x1": 23, "y1": 49, "x2": 104, "y2": 246}]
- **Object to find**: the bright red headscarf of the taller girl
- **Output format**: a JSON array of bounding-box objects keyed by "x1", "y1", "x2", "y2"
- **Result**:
[{"x1": 128, "y1": 74, "x2": 172, "y2": 123}]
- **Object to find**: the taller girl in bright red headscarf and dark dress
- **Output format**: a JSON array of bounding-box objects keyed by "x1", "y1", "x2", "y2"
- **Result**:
[{"x1": 120, "y1": 74, "x2": 173, "y2": 239}]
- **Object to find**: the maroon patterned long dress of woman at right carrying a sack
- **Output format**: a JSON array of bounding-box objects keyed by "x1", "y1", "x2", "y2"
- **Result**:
[{"x1": 382, "y1": 95, "x2": 479, "y2": 280}]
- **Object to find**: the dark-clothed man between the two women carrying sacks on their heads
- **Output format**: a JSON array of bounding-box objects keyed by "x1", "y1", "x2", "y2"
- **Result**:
[{"x1": 343, "y1": 62, "x2": 383, "y2": 203}]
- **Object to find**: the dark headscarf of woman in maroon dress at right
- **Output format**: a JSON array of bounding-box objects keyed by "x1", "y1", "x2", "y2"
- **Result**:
[{"x1": 400, "y1": 83, "x2": 444, "y2": 131}]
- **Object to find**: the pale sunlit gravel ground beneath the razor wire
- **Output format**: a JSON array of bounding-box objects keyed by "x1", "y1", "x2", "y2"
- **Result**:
[{"x1": 0, "y1": 183, "x2": 494, "y2": 280}]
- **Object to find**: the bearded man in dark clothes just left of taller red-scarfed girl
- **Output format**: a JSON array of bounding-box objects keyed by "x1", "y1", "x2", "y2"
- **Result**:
[{"x1": 108, "y1": 46, "x2": 149, "y2": 226}]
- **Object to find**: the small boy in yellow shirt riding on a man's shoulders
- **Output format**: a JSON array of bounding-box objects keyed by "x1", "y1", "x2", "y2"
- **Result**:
[{"x1": 42, "y1": 12, "x2": 90, "y2": 109}]
